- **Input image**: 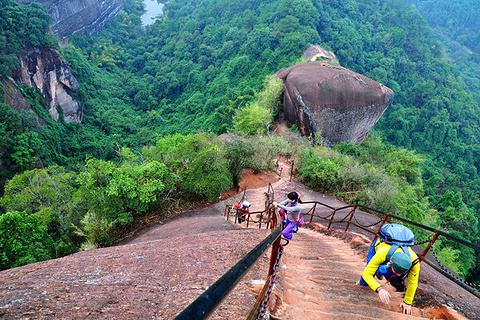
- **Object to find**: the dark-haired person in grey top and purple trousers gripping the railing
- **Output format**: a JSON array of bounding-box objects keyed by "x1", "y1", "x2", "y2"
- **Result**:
[{"x1": 273, "y1": 192, "x2": 305, "y2": 240}]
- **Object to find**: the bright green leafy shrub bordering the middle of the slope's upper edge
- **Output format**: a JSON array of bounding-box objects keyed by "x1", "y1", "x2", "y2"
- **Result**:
[{"x1": 75, "y1": 160, "x2": 175, "y2": 246}]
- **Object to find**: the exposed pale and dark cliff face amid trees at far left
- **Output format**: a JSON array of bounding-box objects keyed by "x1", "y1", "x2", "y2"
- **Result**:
[{"x1": 15, "y1": 48, "x2": 83, "y2": 123}]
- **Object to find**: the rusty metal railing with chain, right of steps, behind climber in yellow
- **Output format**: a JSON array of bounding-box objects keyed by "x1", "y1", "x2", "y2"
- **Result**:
[{"x1": 303, "y1": 201, "x2": 480, "y2": 298}]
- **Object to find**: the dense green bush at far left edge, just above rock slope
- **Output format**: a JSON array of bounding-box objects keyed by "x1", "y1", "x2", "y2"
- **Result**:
[{"x1": 0, "y1": 211, "x2": 55, "y2": 270}]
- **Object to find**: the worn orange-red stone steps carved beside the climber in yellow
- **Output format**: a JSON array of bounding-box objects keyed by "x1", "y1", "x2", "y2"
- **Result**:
[{"x1": 273, "y1": 229, "x2": 430, "y2": 320}]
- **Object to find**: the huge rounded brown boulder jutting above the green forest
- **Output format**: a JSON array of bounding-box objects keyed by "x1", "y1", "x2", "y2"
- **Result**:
[{"x1": 277, "y1": 61, "x2": 393, "y2": 145}]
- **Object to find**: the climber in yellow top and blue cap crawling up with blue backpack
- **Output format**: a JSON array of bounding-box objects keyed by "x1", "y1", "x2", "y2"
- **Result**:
[{"x1": 357, "y1": 223, "x2": 420, "y2": 315}]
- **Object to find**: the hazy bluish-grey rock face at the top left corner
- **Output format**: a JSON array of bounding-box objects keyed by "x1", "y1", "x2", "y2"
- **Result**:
[{"x1": 17, "y1": 0, "x2": 121, "y2": 38}]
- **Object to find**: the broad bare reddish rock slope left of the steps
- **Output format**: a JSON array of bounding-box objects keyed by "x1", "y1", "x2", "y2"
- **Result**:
[{"x1": 0, "y1": 203, "x2": 268, "y2": 320}]
